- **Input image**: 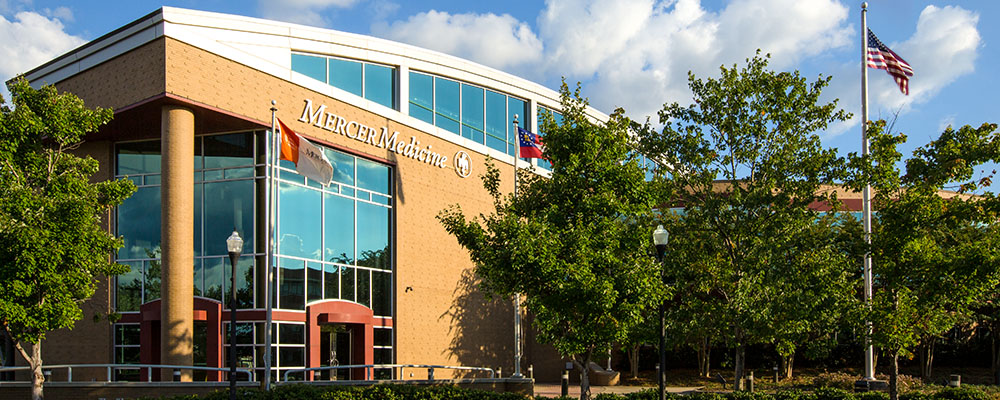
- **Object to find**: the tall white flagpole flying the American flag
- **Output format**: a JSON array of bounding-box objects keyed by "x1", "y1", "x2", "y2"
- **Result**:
[{"x1": 861, "y1": 2, "x2": 875, "y2": 380}]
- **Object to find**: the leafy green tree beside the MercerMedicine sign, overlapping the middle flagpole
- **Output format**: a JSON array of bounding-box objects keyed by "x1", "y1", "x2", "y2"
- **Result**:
[{"x1": 438, "y1": 84, "x2": 663, "y2": 399}]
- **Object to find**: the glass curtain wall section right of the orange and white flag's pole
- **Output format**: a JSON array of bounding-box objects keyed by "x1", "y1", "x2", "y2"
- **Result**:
[{"x1": 276, "y1": 149, "x2": 393, "y2": 378}]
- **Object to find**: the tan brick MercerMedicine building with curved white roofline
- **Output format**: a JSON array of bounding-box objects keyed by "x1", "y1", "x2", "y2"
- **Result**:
[{"x1": 9, "y1": 7, "x2": 603, "y2": 381}]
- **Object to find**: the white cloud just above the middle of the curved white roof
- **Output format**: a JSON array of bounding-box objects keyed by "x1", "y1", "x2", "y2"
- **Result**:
[{"x1": 372, "y1": 11, "x2": 542, "y2": 72}]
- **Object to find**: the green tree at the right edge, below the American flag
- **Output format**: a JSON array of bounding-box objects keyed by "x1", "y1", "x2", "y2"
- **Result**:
[{"x1": 849, "y1": 121, "x2": 1000, "y2": 400}]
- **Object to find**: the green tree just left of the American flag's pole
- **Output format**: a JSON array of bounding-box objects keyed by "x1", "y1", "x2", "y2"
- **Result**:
[{"x1": 640, "y1": 52, "x2": 848, "y2": 383}]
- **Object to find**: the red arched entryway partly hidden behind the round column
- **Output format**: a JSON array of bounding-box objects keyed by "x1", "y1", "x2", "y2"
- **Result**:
[{"x1": 139, "y1": 297, "x2": 222, "y2": 381}]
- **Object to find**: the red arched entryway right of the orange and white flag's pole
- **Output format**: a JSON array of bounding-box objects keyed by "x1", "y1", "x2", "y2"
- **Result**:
[{"x1": 306, "y1": 300, "x2": 375, "y2": 380}]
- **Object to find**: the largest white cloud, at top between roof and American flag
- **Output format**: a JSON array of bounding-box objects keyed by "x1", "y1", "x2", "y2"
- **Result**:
[{"x1": 538, "y1": 0, "x2": 851, "y2": 117}]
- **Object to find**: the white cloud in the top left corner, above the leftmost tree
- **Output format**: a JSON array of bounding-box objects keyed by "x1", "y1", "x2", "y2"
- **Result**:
[{"x1": 0, "y1": 11, "x2": 84, "y2": 100}]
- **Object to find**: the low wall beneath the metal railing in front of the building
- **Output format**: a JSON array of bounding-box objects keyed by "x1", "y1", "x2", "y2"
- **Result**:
[{"x1": 0, "y1": 378, "x2": 534, "y2": 400}]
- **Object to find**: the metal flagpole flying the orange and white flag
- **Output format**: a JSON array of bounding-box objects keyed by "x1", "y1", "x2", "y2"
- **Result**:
[{"x1": 264, "y1": 100, "x2": 278, "y2": 391}]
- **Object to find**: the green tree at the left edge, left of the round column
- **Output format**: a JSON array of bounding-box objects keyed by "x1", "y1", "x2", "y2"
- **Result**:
[{"x1": 0, "y1": 79, "x2": 135, "y2": 399}]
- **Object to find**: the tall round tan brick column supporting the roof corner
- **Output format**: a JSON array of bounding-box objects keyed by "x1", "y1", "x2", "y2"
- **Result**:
[{"x1": 160, "y1": 105, "x2": 194, "y2": 381}]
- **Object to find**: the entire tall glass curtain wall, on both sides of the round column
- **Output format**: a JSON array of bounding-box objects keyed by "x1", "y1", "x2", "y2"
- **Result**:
[{"x1": 114, "y1": 132, "x2": 393, "y2": 380}]
